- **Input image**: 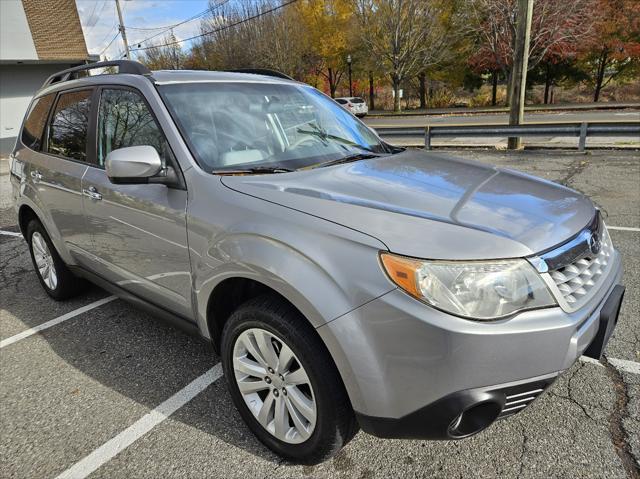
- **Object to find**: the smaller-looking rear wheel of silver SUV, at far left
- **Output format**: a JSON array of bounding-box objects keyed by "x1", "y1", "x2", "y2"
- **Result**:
[{"x1": 26, "y1": 218, "x2": 86, "y2": 301}]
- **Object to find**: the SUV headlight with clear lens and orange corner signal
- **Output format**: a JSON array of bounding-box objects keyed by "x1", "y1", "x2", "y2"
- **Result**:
[{"x1": 380, "y1": 253, "x2": 556, "y2": 320}]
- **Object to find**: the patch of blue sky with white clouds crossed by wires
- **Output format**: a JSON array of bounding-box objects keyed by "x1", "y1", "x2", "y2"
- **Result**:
[{"x1": 76, "y1": 0, "x2": 209, "y2": 60}]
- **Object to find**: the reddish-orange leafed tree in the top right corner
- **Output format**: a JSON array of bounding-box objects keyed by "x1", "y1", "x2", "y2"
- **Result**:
[{"x1": 581, "y1": 0, "x2": 640, "y2": 102}]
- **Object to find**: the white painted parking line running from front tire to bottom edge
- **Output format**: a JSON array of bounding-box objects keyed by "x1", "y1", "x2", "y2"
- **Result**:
[{"x1": 56, "y1": 363, "x2": 222, "y2": 479}]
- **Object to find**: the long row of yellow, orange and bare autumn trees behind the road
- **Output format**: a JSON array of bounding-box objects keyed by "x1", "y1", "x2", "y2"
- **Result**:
[{"x1": 136, "y1": 0, "x2": 640, "y2": 109}]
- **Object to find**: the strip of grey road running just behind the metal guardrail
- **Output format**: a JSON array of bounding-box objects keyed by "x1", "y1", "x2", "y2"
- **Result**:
[{"x1": 364, "y1": 110, "x2": 640, "y2": 128}]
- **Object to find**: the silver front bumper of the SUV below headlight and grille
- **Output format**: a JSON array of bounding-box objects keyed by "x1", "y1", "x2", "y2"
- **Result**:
[{"x1": 318, "y1": 252, "x2": 622, "y2": 439}]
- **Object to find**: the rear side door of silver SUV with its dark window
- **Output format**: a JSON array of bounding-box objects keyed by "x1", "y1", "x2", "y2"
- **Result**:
[{"x1": 23, "y1": 88, "x2": 93, "y2": 263}]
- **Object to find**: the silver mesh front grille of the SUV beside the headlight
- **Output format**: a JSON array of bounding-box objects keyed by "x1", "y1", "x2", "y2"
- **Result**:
[{"x1": 549, "y1": 229, "x2": 613, "y2": 311}]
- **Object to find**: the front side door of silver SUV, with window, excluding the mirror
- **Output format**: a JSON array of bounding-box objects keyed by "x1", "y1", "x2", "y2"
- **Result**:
[{"x1": 83, "y1": 86, "x2": 192, "y2": 318}]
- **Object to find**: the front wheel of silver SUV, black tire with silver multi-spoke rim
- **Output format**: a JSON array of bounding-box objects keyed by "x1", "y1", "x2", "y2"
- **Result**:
[{"x1": 221, "y1": 295, "x2": 358, "y2": 464}]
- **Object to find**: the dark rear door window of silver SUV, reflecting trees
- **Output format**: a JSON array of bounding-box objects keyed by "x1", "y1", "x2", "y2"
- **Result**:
[{"x1": 48, "y1": 90, "x2": 93, "y2": 161}]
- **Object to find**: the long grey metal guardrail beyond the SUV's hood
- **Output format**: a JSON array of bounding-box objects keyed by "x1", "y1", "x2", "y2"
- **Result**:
[{"x1": 375, "y1": 121, "x2": 640, "y2": 151}]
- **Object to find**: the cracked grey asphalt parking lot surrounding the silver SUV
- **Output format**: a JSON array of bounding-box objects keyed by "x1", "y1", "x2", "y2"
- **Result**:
[{"x1": 0, "y1": 150, "x2": 640, "y2": 479}]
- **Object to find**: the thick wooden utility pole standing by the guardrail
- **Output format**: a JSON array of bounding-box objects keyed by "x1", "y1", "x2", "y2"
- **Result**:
[{"x1": 508, "y1": 0, "x2": 533, "y2": 150}]
